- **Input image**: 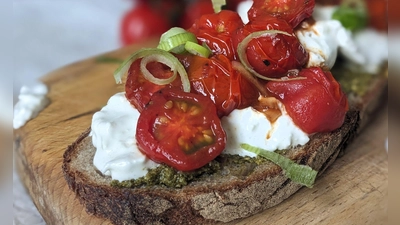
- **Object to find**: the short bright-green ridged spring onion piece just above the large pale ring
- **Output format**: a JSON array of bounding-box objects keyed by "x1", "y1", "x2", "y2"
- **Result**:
[{"x1": 157, "y1": 32, "x2": 197, "y2": 54}]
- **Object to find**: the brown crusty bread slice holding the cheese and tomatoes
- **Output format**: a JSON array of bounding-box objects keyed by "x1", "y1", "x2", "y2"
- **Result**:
[{"x1": 63, "y1": 70, "x2": 387, "y2": 224}]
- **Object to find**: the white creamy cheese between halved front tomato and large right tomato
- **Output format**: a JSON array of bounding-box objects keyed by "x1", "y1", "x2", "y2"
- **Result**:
[{"x1": 221, "y1": 101, "x2": 310, "y2": 157}]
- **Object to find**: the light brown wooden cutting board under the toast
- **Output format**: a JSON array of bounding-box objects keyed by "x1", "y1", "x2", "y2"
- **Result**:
[{"x1": 14, "y1": 41, "x2": 388, "y2": 225}]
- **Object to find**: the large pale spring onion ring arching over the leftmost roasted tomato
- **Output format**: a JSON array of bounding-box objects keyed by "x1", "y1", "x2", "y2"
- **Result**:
[{"x1": 114, "y1": 48, "x2": 190, "y2": 92}]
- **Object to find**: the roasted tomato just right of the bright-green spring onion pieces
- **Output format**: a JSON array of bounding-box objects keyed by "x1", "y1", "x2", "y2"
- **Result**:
[{"x1": 189, "y1": 10, "x2": 243, "y2": 60}]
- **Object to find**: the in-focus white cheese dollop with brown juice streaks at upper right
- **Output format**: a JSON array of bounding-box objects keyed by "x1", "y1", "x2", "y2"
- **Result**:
[{"x1": 296, "y1": 20, "x2": 365, "y2": 69}]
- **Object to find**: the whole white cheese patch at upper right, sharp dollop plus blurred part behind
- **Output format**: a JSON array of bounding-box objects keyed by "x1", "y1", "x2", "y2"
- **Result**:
[{"x1": 310, "y1": 4, "x2": 388, "y2": 74}]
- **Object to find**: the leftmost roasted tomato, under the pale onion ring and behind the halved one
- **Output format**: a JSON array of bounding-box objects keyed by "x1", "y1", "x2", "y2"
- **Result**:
[{"x1": 125, "y1": 59, "x2": 182, "y2": 112}]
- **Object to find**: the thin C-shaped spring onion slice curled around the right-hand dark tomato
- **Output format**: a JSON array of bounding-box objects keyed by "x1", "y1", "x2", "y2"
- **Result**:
[{"x1": 237, "y1": 30, "x2": 304, "y2": 81}]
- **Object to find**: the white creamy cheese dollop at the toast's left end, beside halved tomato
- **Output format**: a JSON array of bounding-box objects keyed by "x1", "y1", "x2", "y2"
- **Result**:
[{"x1": 90, "y1": 93, "x2": 158, "y2": 181}]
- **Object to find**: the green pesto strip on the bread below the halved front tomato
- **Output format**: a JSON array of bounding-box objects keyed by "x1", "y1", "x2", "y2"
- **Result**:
[{"x1": 111, "y1": 155, "x2": 268, "y2": 188}]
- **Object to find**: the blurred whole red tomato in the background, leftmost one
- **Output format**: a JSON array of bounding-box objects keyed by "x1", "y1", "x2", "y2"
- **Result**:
[{"x1": 120, "y1": 2, "x2": 170, "y2": 45}]
